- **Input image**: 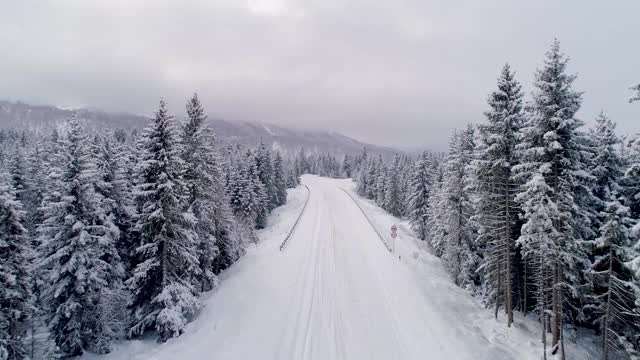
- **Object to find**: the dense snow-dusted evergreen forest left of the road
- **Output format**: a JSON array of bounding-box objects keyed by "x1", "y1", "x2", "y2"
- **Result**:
[{"x1": 0, "y1": 95, "x2": 340, "y2": 360}]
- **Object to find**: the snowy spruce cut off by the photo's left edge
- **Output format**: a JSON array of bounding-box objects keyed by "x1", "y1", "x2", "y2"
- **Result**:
[{"x1": 0, "y1": 171, "x2": 33, "y2": 360}]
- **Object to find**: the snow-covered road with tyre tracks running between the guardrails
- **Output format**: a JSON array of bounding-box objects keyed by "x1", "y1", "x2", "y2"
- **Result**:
[{"x1": 265, "y1": 178, "x2": 472, "y2": 359}]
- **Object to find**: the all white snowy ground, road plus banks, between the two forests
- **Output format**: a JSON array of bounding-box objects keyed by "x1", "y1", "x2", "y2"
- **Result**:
[{"x1": 84, "y1": 175, "x2": 590, "y2": 360}]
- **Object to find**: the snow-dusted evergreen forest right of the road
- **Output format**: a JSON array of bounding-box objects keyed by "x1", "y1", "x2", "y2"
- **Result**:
[{"x1": 356, "y1": 41, "x2": 640, "y2": 359}]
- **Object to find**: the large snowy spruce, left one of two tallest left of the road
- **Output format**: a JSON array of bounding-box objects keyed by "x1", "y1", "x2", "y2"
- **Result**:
[{"x1": 126, "y1": 100, "x2": 199, "y2": 341}]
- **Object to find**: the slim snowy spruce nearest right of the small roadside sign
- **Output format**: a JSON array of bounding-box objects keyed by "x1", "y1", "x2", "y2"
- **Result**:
[{"x1": 407, "y1": 151, "x2": 434, "y2": 240}]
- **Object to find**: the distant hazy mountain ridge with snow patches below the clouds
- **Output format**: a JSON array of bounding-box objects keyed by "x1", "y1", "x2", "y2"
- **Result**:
[{"x1": 0, "y1": 100, "x2": 401, "y2": 158}]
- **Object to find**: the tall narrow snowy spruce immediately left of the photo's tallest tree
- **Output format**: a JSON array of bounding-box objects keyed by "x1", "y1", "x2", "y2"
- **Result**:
[{"x1": 474, "y1": 64, "x2": 526, "y2": 326}]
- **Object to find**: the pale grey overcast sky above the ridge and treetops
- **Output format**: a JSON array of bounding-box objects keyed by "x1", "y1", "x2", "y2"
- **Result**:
[{"x1": 0, "y1": 0, "x2": 640, "y2": 149}]
